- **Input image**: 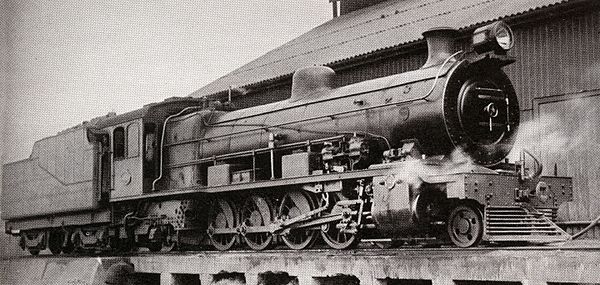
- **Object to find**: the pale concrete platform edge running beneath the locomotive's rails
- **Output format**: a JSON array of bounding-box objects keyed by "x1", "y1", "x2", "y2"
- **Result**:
[{"x1": 0, "y1": 247, "x2": 600, "y2": 285}]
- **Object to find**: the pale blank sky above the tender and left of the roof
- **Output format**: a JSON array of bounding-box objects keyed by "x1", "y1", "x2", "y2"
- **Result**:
[{"x1": 0, "y1": 0, "x2": 331, "y2": 163}]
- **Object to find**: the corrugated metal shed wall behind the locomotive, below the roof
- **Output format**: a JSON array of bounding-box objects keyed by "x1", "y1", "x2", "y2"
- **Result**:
[{"x1": 229, "y1": 8, "x2": 600, "y2": 233}]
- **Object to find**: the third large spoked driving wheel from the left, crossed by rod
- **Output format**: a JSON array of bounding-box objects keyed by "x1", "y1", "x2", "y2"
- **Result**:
[{"x1": 278, "y1": 191, "x2": 319, "y2": 250}]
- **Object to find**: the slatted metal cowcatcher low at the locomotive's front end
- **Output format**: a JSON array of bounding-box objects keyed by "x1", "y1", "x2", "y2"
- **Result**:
[{"x1": 483, "y1": 206, "x2": 571, "y2": 244}]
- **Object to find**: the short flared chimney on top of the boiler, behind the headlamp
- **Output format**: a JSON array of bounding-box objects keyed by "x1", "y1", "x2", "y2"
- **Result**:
[{"x1": 421, "y1": 27, "x2": 458, "y2": 68}]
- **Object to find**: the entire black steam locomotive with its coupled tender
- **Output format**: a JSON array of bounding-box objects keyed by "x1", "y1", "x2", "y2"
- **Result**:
[{"x1": 2, "y1": 22, "x2": 572, "y2": 255}]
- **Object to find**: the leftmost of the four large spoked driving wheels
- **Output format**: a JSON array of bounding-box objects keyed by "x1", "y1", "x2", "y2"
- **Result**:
[{"x1": 209, "y1": 196, "x2": 238, "y2": 250}]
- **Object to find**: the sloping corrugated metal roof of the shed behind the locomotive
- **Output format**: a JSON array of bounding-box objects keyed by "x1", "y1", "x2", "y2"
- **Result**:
[{"x1": 192, "y1": 0, "x2": 569, "y2": 97}]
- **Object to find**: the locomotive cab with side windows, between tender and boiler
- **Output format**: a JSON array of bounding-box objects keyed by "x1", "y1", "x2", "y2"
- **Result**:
[{"x1": 95, "y1": 98, "x2": 201, "y2": 199}]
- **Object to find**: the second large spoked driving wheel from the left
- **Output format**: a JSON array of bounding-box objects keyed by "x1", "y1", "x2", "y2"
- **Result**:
[{"x1": 241, "y1": 195, "x2": 275, "y2": 250}]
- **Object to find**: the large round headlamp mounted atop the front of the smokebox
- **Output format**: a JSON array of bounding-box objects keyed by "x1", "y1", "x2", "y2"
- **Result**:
[{"x1": 473, "y1": 21, "x2": 515, "y2": 54}]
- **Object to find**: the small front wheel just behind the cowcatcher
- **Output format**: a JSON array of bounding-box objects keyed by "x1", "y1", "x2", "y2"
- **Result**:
[{"x1": 447, "y1": 205, "x2": 483, "y2": 247}]
